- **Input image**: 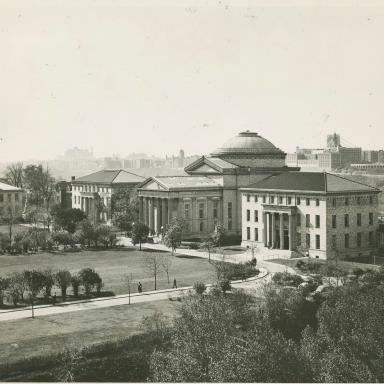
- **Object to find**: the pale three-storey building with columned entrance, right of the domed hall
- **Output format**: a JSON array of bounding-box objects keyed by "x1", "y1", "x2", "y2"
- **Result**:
[{"x1": 242, "y1": 172, "x2": 380, "y2": 259}]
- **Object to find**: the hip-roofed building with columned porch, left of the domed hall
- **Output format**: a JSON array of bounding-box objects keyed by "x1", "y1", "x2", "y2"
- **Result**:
[{"x1": 71, "y1": 169, "x2": 145, "y2": 224}]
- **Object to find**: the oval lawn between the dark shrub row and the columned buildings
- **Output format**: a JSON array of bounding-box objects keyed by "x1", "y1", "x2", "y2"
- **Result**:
[{"x1": 0, "y1": 248, "x2": 216, "y2": 295}]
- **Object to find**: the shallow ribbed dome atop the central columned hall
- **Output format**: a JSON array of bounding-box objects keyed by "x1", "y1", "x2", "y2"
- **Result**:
[{"x1": 211, "y1": 131, "x2": 285, "y2": 156}]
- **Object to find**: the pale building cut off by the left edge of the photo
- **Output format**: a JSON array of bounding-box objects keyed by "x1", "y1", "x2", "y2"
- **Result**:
[{"x1": 0, "y1": 182, "x2": 25, "y2": 221}]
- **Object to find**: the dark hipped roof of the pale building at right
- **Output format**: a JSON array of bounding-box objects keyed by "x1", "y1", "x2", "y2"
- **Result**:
[{"x1": 243, "y1": 172, "x2": 379, "y2": 193}]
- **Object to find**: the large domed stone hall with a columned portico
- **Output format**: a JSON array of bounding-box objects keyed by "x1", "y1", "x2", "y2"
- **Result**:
[{"x1": 139, "y1": 131, "x2": 298, "y2": 238}]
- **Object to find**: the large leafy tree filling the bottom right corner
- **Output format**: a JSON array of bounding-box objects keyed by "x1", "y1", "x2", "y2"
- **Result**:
[{"x1": 301, "y1": 284, "x2": 384, "y2": 382}]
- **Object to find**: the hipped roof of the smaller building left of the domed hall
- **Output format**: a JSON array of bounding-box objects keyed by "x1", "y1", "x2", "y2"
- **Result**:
[{"x1": 72, "y1": 169, "x2": 145, "y2": 184}]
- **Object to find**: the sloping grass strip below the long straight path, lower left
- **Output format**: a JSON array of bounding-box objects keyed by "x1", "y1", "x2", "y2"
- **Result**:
[{"x1": 0, "y1": 300, "x2": 179, "y2": 363}]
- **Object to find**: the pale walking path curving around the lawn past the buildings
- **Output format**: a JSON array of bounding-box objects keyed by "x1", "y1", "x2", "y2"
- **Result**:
[{"x1": 0, "y1": 237, "x2": 295, "y2": 321}]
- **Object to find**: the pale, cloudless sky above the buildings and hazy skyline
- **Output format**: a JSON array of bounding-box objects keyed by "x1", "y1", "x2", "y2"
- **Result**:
[{"x1": 0, "y1": 0, "x2": 384, "y2": 161}]
